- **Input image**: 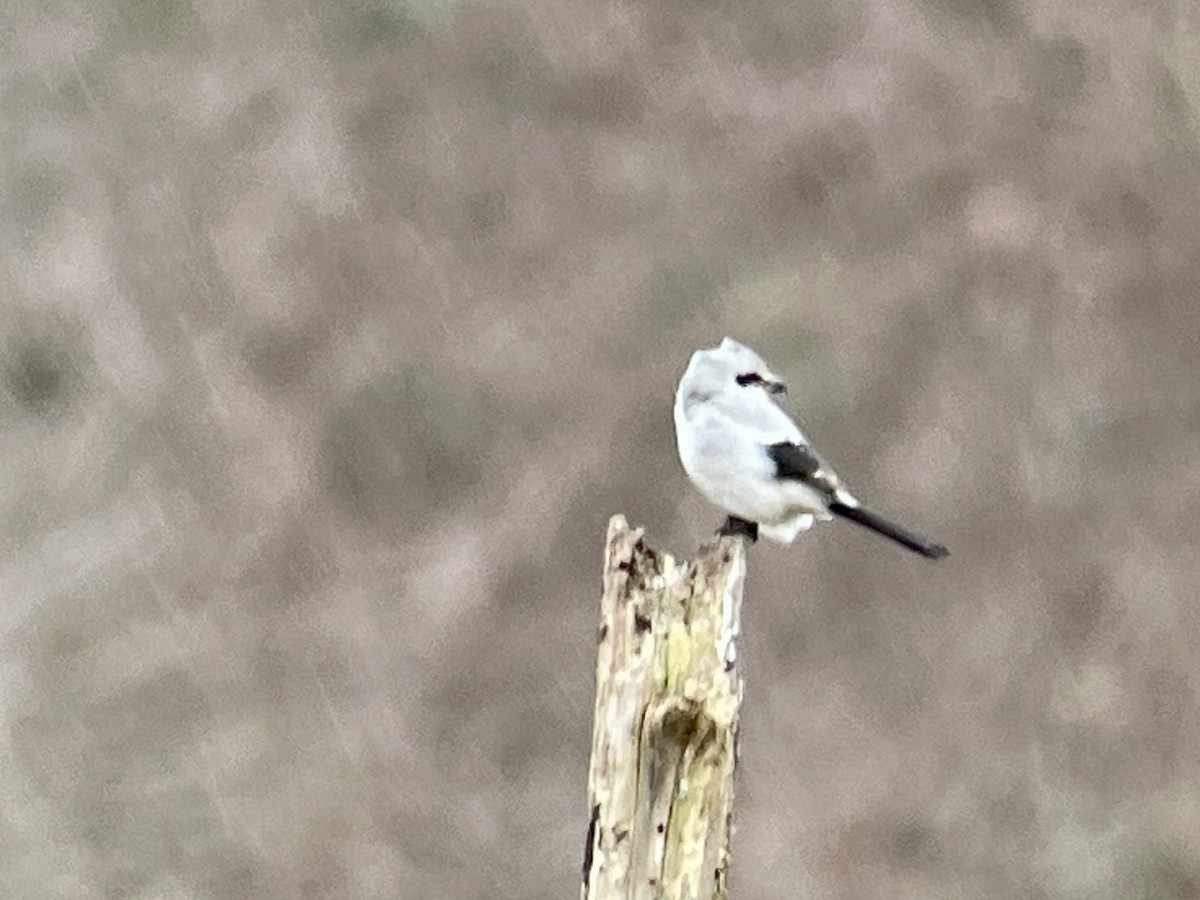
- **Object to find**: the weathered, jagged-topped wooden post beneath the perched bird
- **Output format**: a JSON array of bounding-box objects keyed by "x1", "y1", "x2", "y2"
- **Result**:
[{"x1": 581, "y1": 516, "x2": 746, "y2": 900}]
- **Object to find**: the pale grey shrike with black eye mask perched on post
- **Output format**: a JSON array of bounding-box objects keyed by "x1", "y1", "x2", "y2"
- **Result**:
[{"x1": 674, "y1": 337, "x2": 949, "y2": 559}]
